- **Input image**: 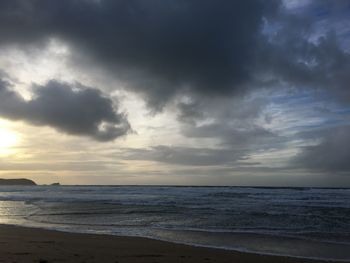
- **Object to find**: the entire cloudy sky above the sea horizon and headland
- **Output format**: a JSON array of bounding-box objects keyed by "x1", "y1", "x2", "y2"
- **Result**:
[{"x1": 0, "y1": 0, "x2": 350, "y2": 187}]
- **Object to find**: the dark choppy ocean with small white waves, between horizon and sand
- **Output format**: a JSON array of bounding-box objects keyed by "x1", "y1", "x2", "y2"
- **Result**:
[{"x1": 0, "y1": 186, "x2": 350, "y2": 261}]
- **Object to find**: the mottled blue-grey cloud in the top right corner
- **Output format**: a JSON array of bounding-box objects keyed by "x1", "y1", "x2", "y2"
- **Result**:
[{"x1": 255, "y1": 1, "x2": 350, "y2": 102}]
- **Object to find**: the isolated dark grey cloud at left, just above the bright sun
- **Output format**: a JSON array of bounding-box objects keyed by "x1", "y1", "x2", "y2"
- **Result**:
[{"x1": 0, "y1": 80, "x2": 130, "y2": 141}]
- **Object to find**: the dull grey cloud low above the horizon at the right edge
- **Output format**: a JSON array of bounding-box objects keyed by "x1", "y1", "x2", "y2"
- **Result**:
[{"x1": 291, "y1": 126, "x2": 350, "y2": 175}]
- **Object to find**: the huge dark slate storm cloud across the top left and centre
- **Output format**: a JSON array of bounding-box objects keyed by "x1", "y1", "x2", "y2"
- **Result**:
[{"x1": 0, "y1": 0, "x2": 277, "y2": 108}]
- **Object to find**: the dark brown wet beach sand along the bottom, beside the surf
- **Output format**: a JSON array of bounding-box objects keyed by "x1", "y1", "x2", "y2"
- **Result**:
[{"x1": 0, "y1": 225, "x2": 340, "y2": 263}]
